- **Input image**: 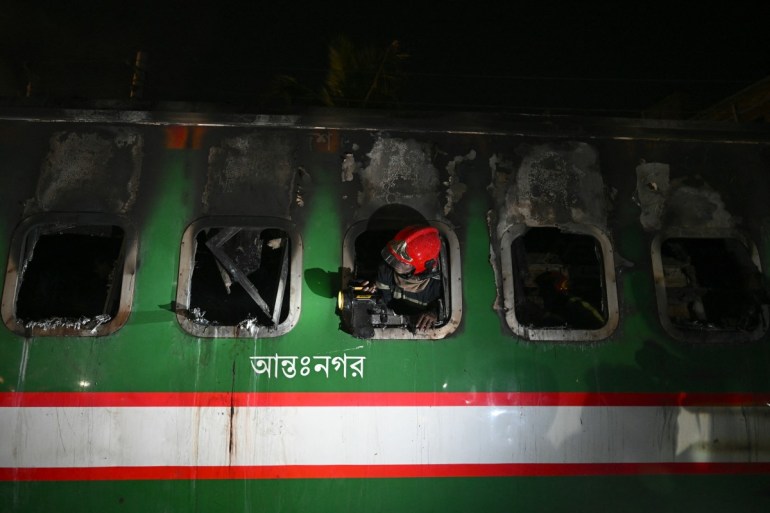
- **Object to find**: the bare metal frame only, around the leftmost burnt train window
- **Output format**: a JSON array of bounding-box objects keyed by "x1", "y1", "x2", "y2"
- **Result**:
[{"x1": 2, "y1": 213, "x2": 139, "y2": 337}]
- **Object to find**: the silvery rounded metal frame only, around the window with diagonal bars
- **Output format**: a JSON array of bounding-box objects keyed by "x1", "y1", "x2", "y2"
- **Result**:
[{"x1": 176, "y1": 216, "x2": 302, "y2": 339}]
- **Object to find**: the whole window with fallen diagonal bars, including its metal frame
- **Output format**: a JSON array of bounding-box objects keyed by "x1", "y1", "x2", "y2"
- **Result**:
[{"x1": 176, "y1": 217, "x2": 302, "y2": 338}]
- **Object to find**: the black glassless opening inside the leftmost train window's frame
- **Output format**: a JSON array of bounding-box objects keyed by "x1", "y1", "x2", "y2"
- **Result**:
[{"x1": 16, "y1": 226, "x2": 125, "y2": 322}]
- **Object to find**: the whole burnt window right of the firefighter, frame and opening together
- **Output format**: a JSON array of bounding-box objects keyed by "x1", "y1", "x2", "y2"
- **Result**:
[{"x1": 501, "y1": 225, "x2": 618, "y2": 341}]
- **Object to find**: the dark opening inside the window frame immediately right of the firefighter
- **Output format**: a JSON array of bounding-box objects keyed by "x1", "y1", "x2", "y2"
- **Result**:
[{"x1": 511, "y1": 227, "x2": 608, "y2": 330}]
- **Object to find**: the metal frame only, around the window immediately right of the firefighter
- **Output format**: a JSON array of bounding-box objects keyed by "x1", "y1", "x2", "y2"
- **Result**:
[{"x1": 500, "y1": 224, "x2": 620, "y2": 342}]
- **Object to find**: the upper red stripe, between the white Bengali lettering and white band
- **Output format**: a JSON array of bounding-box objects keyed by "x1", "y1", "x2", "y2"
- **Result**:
[{"x1": 0, "y1": 392, "x2": 770, "y2": 407}]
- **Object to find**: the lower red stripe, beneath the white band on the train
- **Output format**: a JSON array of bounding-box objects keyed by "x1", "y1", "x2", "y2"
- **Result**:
[{"x1": 0, "y1": 463, "x2": 770, "y2": 481}]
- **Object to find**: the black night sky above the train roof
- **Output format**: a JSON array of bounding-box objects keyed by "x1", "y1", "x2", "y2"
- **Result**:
[{"x1": 0, "y1": 0, "x2": 770, "y2": 117}]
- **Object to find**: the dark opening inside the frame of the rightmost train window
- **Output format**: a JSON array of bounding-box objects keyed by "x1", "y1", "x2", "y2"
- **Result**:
[{"x1": 660, "y1": 238, "x2": 770, "y2": 331}]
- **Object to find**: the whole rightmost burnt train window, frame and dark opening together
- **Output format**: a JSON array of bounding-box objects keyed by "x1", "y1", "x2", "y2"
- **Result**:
[{"x1": 652, "y1": 230, "x2": 770, "y2": 342}]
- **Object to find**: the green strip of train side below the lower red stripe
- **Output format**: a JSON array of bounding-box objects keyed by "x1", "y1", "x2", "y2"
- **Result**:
[{"x1": 0, "y1": 475, "x2": 770, "y2": 513}]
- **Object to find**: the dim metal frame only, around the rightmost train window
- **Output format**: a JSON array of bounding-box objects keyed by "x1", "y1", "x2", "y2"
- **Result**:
[{"x1": 650, "y1": 228, "x2": 770, "y2": 343}]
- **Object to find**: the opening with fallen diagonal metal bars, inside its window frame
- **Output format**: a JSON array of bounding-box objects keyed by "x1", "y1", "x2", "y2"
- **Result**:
[{"x1": 189, "y1": 227, "x2": 291, "y2": 327}]
